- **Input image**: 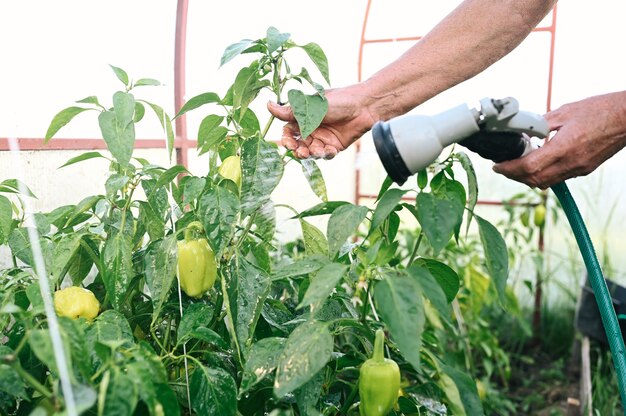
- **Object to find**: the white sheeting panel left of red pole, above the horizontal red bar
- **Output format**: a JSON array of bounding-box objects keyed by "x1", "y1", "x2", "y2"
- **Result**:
[{"x1": 0, "y1": 0, "x2": 176, "y2": 138}]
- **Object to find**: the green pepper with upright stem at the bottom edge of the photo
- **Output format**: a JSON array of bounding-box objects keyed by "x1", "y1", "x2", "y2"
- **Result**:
[{"x1": 359, "y1": 329, "x2": 400, "y2": 416}]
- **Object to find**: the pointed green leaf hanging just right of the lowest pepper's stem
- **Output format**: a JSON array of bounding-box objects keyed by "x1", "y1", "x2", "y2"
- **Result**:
[{"x1": 374, "y1": 271, "x2": 424, "y2": 370}]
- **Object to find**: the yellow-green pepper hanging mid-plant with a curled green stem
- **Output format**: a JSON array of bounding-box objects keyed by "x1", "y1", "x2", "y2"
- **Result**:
[{"x1": 178, "y1": 221, "x2": 217, "y2": 298}]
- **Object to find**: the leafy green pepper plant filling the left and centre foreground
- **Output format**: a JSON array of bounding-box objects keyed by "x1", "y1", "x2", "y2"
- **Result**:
[{"x1": 0, "y1": 27, "x2": 508, "y2": 416}]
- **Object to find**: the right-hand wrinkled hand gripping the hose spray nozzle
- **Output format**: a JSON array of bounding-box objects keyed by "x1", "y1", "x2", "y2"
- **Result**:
[{"x1": 493, "y1": 91, "x2": 626, "y2": 189}]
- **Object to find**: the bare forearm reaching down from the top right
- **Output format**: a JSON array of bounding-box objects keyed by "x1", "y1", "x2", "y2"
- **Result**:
[{"x1": 359, "y1": 0, "x2": 556, "y2": 120}]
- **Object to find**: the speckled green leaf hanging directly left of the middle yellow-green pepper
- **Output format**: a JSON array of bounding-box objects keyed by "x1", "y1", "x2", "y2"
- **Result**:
[{"x1": 144, "y1": 234, "x2": 177, "y2": 322}]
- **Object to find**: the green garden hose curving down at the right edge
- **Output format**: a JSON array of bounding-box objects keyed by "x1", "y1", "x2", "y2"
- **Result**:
[{"x1": 552, "y1": 182, "x2": 626, "y2": 415}]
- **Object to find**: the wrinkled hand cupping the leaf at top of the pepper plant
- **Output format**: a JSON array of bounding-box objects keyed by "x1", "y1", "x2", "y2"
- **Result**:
[{"x1": 267, "y1": 84, "x2": 376, "y2": 159}]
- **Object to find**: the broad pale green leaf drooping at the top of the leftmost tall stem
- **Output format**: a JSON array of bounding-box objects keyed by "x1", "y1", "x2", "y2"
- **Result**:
[{"x1": 98, "y1": 111, "x2": 135, "y2": 167}]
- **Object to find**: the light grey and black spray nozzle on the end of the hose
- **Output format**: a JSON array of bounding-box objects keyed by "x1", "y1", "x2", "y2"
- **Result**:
[{"x1": 372, "y1": 97, "x2": 550, "y2": 184}]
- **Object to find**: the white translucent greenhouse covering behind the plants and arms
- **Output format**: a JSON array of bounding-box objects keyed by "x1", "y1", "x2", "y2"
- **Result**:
[{"x1": 0, "y1": 0, "x2": 626, "y2": 286}]
